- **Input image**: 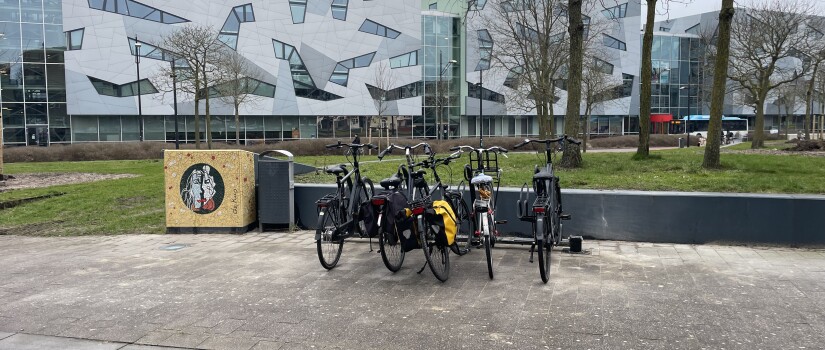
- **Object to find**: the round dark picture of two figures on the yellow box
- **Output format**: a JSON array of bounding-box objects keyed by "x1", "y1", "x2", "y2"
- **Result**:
[{"x1": 180, "y1": 163, "x2": 224, "y2": 214}]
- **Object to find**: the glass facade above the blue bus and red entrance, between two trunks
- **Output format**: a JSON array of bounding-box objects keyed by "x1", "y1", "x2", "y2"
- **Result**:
[{"x1": 650, "y1": 35, "x2": 703, "y2": 123}]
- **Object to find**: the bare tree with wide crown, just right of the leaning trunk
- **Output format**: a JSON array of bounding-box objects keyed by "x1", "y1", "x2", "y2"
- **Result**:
[{"x1": 728, "y1": 0, "x2": 813, "y2": 148}]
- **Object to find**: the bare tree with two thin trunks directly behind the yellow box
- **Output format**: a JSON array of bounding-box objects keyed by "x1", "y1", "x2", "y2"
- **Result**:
[{"x1": 161, "y1": 24, "x2": 226, "y2": 149}]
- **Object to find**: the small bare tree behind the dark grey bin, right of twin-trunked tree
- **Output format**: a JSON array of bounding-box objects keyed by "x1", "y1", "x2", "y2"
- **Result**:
[{"x1": 214, "y1": 49, "x2": 264, "y2": 144}]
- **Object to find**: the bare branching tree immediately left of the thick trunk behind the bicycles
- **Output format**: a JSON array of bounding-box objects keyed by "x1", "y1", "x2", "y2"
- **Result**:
[{"x1": 483, "y1": 0, "x2": 569, "y2": 138}]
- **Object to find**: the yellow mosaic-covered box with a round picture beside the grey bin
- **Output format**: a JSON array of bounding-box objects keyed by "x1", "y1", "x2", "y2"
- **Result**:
[{"x1": 163, "y1": 150, "x2": 257, "y2": 233}]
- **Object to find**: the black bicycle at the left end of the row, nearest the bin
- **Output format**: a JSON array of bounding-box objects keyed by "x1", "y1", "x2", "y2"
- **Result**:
[{"x1": 315, "y1": 136, "x2": 378, "y2": 270}]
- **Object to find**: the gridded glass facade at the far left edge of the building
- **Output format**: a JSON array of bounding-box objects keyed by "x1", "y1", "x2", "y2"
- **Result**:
[{"x1": 0, "y1": 0, "x2": 66, "y2": 146}]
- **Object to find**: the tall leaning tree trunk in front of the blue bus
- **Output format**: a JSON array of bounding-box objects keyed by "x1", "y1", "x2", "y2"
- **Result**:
[{"x1": 702, "y1": 0, "x2": 734, "y2": 169}]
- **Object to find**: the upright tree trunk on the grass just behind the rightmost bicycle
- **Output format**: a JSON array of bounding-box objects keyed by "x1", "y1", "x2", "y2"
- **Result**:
[{"x1": 560, "y1": 0, "x2": 584, "y2": 168}]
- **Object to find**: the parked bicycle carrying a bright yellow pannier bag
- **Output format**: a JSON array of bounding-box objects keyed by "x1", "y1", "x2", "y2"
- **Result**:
[{"x1": 379, "y1": 142, "x2": 470, "y2": 282}]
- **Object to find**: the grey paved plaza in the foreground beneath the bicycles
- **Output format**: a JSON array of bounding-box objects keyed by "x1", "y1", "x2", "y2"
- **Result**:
[{"x1": 0, "y1": 231, "x2": 825, "y2": 350}]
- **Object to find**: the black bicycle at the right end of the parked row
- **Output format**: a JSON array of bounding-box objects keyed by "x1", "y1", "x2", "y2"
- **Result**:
[{"x1": 513, "y1": 135, "x2": 581, "y2": 283}]
